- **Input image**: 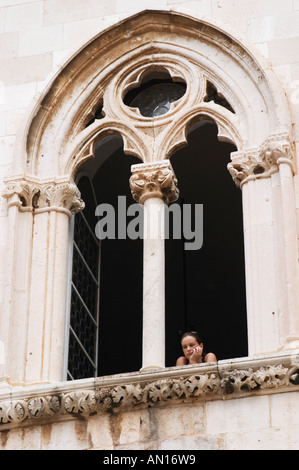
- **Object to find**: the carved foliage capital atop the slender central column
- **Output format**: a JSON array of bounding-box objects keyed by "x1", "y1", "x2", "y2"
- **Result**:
[{"x1": 130, "y1": 160, "x2": 179, "y2": 204}]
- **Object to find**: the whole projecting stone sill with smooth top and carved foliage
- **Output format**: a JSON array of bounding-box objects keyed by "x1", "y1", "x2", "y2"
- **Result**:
[{"x1": 0, "y1": 351, "x2": 299, "y2": 430}]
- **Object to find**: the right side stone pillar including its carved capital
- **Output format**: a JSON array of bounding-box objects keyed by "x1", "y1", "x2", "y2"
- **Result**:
[{"x1": 228, "y1": 138, "x2": 299, "y2": 355}]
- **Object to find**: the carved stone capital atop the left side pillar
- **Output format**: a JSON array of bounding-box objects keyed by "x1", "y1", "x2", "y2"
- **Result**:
[{"x1": 2, "y1": 179, "x2": 84, "y2": 216}]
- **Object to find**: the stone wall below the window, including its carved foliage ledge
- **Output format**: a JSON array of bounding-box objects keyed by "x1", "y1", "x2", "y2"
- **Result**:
[{"x1": 0, "y1": 355, "x2": 299, "y2": 451}]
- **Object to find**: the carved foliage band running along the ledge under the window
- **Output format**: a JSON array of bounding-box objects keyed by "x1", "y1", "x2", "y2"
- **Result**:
[{"x1": 0, "y1": 363, "x2": 299, "y2": 426}]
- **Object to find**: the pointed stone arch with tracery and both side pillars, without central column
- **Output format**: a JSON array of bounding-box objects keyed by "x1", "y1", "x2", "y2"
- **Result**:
[{"x1": 4, "y1": 10, "x2": 299, "y2": 383}]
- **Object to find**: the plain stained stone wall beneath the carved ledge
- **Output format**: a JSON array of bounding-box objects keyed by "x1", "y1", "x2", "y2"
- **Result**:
[{"x1": 0, "y1": 392, "x2": 299, "y2": 451}]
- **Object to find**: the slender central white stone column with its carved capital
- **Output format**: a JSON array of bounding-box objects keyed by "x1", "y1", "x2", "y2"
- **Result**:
[{"x1": 130, "y1": 160, "x2": 178, "y2": 370}]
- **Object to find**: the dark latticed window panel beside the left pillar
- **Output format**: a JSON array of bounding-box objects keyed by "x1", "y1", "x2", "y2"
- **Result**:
[{"x1": 67, "y1": 176, "x2": 100, "y2": 379}]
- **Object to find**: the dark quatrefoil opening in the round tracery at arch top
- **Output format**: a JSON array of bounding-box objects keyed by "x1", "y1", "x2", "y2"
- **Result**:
[{"x1": 124, "y1": 73, "x2": 186, "y2": 118}]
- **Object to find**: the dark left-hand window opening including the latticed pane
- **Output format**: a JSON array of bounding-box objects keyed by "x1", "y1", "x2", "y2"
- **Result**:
[{"x1": 68, "y1": 136, "x2": 143, "y2": 379}]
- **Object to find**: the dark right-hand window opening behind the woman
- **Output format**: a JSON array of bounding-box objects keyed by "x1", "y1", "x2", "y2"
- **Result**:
[{"x1": 166, "y1": 124, "x2": 248, "y2": 366}]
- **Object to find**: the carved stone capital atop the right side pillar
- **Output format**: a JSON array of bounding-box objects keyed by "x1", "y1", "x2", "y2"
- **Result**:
[{"x1": 227, "y1": 136, "x2": 294, "y2": 187}]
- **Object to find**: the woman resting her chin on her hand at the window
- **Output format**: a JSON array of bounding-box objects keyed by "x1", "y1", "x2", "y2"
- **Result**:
[{"x1": 176, "y1": 331, "x2": 217, "y2": 366}]
